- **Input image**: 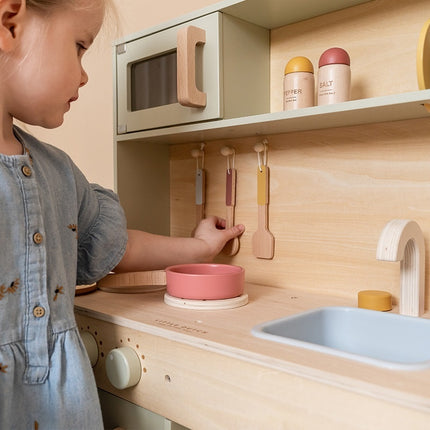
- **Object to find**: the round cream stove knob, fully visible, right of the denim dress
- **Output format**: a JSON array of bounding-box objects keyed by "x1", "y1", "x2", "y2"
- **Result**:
[{"x1": 106, "y1": 346, "x2": 142, "y2": 390}]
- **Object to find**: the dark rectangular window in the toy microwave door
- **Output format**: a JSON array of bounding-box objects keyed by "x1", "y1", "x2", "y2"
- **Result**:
[{"x1": 130, "y1": 51, "x2": 178, "y2": 111}]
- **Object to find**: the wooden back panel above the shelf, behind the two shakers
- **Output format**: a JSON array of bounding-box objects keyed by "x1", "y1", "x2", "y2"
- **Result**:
[{"x1": 270, "y1": 0, "x2": 430, "y2": 112}]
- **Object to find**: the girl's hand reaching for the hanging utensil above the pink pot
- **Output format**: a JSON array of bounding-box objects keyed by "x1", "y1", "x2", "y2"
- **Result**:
[{"x1": 193, "y1": 216, "x2": 245, "y2": 261}]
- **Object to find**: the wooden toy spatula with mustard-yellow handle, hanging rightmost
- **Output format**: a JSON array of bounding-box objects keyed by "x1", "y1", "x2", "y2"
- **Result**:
[{"x1": 252, "y1": 165, "x2": 275, "y2": 260}]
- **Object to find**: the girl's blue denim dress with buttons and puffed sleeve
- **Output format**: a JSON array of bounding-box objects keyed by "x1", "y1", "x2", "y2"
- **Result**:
[{"x1": 0, "y1": 128, "x2": 127, "y2": 430}]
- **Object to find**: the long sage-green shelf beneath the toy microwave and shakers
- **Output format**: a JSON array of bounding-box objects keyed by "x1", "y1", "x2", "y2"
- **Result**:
[{"x1": 117, "y1": 90, "x2": 430, "y2": 144}]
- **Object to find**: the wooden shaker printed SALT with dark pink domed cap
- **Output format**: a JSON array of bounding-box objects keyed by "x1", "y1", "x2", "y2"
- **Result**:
[{"x1": 317, "y1": 48, "x2": 351, "y2": 106}]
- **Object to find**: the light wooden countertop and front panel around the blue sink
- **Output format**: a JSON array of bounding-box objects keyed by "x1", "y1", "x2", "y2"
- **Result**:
[{"x1": 76, "y1": 284, "x2": 430, "y2": 430}]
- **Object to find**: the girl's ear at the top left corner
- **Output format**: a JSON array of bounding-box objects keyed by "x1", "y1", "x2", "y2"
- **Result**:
[{"x1": 0, "y1": 0, "x2": 25, "y2": 52}]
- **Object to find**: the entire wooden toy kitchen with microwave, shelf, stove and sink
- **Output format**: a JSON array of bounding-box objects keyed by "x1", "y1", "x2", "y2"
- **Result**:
[{"x1": 76, "y1": 0, "x2": 430, "y2": 430}]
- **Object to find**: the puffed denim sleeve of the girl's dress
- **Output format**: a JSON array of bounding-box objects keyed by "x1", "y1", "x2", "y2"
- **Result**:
[{"x1": 77, "y1": 183, "x2": 127, "y2": 284}]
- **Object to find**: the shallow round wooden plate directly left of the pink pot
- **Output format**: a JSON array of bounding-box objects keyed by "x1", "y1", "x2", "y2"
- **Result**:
[{"x1": 97, "y1": 270, "x2": 166, "y2": 293}]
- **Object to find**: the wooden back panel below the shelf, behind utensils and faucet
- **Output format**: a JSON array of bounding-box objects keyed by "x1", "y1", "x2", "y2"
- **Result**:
[{"x1": 170, "y1": 119, "x2": 430, "y2": 308}]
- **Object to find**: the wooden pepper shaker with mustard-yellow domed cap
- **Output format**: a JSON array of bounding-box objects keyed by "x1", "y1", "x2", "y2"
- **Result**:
[{"x1": 284, "y1": 57, "x2": 315, "y2": 110}]
